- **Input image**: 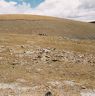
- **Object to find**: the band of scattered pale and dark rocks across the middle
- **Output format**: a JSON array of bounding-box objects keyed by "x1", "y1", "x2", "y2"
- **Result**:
[{"x1": 0, "y1": 45, "x2": 95, "y2": 65}]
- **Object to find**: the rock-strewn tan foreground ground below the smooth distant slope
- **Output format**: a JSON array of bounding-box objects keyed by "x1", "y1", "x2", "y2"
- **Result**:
[{"x1": 0, "y1": 34, "x2": 95, "y2": 96}]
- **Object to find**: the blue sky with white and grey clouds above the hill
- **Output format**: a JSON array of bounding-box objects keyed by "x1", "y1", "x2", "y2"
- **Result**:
[{"x1": 0, "y1": 0, "x2": 95, "y2": 21}]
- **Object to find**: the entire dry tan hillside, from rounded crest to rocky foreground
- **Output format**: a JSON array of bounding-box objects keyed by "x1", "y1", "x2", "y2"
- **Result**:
[{"x1": 0, "y1": 15, "x2": 95, "y2": 96}]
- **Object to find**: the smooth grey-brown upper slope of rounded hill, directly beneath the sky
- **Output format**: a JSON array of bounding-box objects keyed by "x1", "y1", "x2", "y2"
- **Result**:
[{"x1": 0, "y1": 15, "x2": 95, "y2": 39}]
